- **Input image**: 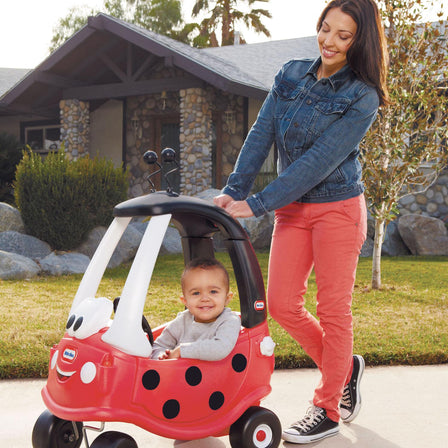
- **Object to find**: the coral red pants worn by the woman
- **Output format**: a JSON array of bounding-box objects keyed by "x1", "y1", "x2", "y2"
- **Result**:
[{"x1": 267, "y1": 195, "x2": 367, "y2": 421}]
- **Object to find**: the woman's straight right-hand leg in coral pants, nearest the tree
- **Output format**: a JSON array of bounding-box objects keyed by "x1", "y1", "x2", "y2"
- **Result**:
[{"x1": 310, "y1": 196, "x2": 367, "y2": 421}]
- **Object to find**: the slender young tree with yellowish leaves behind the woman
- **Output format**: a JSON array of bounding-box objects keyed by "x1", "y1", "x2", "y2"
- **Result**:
[{"x1": 361, "y1": 0, "x2": 448, "y2": 289}]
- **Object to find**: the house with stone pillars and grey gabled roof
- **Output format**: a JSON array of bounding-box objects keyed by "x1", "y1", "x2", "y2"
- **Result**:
[{"x1": 0, "y1": 14, "x2": 318, "y2": 197}]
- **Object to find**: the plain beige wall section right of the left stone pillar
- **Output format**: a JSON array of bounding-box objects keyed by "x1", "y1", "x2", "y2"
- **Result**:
[{"x1": 89, "y1": 100, "x2": 123, "y2": 167}]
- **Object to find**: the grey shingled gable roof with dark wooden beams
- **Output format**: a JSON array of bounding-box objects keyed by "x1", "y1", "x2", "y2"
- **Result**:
[{"x1": 0, "y1": 13, "x2": 318, "y2": 117}]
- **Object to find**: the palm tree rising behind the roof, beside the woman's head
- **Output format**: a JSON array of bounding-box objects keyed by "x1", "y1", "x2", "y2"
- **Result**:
[{"x1": 192, "y1": 0, "x2": 272, "y2": 47}]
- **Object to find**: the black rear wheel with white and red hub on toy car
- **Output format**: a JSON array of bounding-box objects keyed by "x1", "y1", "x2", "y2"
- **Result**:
[{"x1": 229, "y1": 406, "x2": 282, "y2": 448}]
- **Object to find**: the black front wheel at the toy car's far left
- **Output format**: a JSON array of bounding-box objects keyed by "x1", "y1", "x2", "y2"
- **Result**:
[{"x1": 32, "y1": 410, "x2": 82, "y2": 448}]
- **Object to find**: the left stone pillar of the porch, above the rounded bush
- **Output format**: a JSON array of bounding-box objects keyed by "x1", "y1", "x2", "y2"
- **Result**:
[{"x1": 59, "y1": 99, "x2": 90, "y2": 160}]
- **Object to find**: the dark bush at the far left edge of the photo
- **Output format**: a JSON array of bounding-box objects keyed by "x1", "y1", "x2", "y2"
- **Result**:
[{"x1": 0, "y1": 132, "x2": 22, "y2": 204}]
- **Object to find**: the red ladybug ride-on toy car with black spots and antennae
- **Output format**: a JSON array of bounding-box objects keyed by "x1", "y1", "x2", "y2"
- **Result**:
[{"x1": 32, "y1": 149, "x2": 281, "y2": 448}]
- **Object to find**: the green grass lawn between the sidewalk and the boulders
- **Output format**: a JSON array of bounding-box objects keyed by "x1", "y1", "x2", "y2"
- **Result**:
[{"x1": 0, "y1": 253, "x2": 448, "y2": 379}]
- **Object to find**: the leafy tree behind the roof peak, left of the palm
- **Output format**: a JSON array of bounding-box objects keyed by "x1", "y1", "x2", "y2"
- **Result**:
[{"x1": 50, "y1": 0, "x2": 199, "y2": 52}]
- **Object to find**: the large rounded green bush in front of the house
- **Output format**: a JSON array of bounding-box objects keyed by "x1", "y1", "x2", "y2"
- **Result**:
[{"x1": 14, "y1": 150, "x2": 128, "y2": 250}]
